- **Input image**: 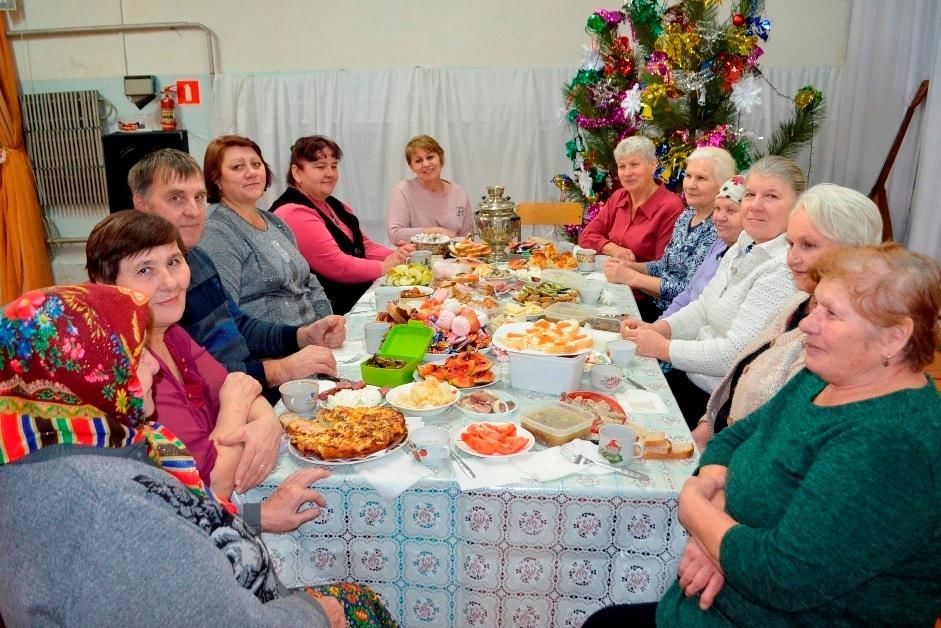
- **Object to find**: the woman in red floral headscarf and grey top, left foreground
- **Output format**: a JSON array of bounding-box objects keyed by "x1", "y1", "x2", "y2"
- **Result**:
[{"x1": 0, "y1": 284, "x2": 393, "y2": 628}]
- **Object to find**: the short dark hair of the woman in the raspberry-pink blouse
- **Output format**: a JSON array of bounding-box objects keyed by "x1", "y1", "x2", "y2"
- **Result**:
[{"x1": 85, "y1": 209, "x2": 186, "y2": 285}]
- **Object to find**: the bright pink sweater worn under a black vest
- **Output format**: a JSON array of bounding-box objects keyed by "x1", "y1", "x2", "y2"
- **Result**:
[{"x1": 274, "y1": 201, "x2": 392, "y2": 283}]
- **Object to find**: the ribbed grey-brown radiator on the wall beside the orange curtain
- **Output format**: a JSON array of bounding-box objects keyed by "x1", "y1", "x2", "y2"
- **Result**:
[{"x1": 23, "y1": 90, "x2": 108, "y2": 211}]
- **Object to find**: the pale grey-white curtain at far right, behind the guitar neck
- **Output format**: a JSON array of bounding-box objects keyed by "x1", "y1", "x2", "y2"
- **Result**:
[{"x1": 833, "y1": 0, "x2": 941, "y2": 259}]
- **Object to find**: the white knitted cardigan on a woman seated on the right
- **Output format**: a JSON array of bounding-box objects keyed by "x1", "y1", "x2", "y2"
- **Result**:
[{"x1": 664, "y1": 231, "x2": 797, "y2": 392}]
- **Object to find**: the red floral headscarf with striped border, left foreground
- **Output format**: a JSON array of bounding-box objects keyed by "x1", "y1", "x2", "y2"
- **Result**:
[{"x1": 0, "y1": 284, "x2": 231, "y2": 509}]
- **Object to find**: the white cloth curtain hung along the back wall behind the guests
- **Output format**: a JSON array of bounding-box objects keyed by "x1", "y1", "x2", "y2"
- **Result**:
[{"x1": 212, "y1": 66, "x2": 839, "y2": 247}]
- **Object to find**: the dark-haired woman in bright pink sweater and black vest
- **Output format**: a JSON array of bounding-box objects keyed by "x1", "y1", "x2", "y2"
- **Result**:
[{"x1": 271, "y1": 135, "x2": 415, "y2": 314}]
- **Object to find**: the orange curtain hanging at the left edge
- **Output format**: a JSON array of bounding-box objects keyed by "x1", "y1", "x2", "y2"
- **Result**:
[{"x1": 0, "y1": 18, "x2": 52, "y2": 305}]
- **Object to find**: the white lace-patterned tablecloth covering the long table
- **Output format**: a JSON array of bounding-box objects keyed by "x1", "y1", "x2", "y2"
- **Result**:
[{"x1": 246, "y1": 284, "x2": 695, "y2": 628}]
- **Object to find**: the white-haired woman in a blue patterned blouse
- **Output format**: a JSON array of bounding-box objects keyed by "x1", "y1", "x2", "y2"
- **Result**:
[{"x1": 604, "y1": 146, "x2": 735, "y2": 323}]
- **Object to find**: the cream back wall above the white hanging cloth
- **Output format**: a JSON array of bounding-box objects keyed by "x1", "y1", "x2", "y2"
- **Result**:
[{"x1": 9, "y1": 0, "x2": 850, "y2": 258}]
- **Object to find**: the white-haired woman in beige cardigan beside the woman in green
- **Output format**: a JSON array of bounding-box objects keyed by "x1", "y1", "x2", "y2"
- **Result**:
[{"x1": 693, "y1": 183, "x2": 882, "y2": 449}]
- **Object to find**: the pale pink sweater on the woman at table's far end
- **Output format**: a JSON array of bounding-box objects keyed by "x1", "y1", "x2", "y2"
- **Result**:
[{"x1": 388, "y1": 179, "x2": 474, "y2": 243}]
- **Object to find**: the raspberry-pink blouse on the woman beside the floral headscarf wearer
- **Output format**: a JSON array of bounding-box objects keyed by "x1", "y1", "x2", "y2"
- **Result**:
[{"x1": 154, "y1": 325, "x2": 229, "y2": 486}]
